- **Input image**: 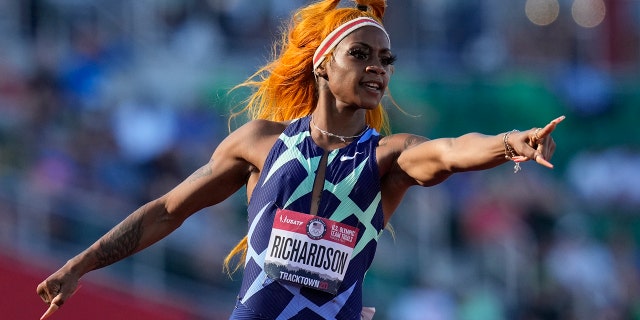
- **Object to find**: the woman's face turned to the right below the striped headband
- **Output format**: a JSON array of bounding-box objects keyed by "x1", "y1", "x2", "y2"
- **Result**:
[{"x1": 325, "y1": 26, "x2": 395, "y2": 109}]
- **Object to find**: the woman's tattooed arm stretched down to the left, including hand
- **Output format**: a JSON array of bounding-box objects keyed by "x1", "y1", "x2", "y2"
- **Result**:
[{"x1": 37, "y1": 120, "x2": 266, "y2": 319}]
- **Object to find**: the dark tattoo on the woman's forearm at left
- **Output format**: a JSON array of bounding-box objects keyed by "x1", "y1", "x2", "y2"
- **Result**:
[{"x1": 95, "y1": 215, "x2": 143, "y2": 269}]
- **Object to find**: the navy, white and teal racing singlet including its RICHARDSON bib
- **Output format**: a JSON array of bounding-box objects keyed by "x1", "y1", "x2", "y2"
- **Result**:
[{"x1": 231, "y1": 117, "x2": 383, "y2": 320}]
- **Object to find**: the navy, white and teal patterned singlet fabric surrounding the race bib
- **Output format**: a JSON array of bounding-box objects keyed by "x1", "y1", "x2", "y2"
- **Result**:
[{"x1": 231, "y1": 117, "x2": 384, "y2": 320}]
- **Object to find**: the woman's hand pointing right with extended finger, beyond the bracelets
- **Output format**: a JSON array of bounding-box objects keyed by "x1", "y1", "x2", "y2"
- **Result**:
[{"x1": 507, "y1": 116, "x2": 565, "y2": 168}]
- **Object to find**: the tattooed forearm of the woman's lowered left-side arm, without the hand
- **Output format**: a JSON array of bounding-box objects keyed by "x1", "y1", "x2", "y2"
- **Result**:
[{"x1": 65, "y1": 200, "x2": 182, "y2": 276}]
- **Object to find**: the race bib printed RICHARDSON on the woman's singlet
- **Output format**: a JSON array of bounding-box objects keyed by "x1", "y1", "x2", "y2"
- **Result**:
[{"x1": 264, "y1": 209, "x2": 358, "y2": 294}]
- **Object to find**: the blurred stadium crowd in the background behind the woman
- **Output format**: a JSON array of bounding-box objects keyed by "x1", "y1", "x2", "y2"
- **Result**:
[{"x1": 0, "y1": 0, "x2": 640, "y2": 320}]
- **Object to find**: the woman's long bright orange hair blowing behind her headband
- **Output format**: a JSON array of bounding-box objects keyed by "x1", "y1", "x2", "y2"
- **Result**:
[{"x1": 223, "y1": 0, "x2": 390, "y2": 274}]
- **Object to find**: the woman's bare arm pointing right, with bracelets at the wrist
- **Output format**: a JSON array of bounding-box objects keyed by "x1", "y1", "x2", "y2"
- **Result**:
[{"x1": 397, "y1": 116, "x2": 564, "y2": 186}]
